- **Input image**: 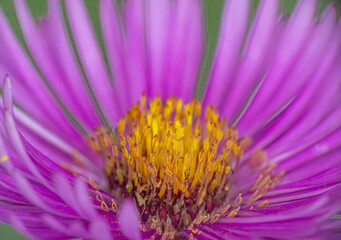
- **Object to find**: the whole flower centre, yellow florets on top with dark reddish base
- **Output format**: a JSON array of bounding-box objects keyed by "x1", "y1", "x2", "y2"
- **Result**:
[{"x1": 92, "y1": 96, "x2": 243, "y2": 236}]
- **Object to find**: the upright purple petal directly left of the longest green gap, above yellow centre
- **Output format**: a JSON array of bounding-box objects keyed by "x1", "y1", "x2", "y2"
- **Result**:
[{"x1": 163, "y1": 0, "x2": 204, "y2": 101}]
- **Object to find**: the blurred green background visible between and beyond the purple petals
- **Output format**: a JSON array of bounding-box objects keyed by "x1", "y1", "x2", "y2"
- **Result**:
[{"x1": 0, "y1": 0, "x2": 341, "y2": 240}]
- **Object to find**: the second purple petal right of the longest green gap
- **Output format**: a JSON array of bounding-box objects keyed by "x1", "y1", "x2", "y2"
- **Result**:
[{"x1": 222, "y1": 0, "x2": 281, "y2": 119}]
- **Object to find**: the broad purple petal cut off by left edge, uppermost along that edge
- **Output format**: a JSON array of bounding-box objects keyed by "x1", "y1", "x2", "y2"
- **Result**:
[{"x1": 0, "y1": 8, "x2": 84, "y2": 146}]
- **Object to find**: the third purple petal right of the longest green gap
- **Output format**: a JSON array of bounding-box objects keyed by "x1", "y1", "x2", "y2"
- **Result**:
[{"x1": 238, "y1": 0, "x2": 316, "y2": 134}]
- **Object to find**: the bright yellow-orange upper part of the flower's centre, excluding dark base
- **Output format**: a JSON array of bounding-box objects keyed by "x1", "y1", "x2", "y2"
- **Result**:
[{"x1": 101, "y1": 96, "x2": 241, "y2": 201}]
